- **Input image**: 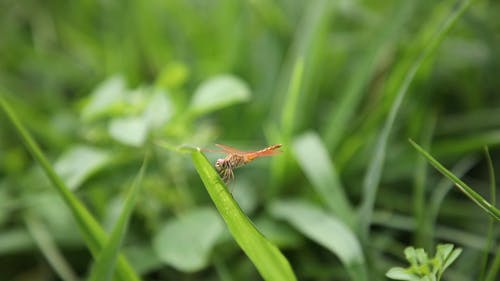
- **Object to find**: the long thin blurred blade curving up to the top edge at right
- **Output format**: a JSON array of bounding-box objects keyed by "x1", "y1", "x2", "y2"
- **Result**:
[{"x1": 359, "y1": 1, "x2": 471, "y2": 237}]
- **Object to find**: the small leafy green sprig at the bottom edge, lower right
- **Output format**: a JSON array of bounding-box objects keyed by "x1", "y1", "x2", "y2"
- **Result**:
[{"x1": 386, "y1": 244, "x2": 462, "y2": 281}]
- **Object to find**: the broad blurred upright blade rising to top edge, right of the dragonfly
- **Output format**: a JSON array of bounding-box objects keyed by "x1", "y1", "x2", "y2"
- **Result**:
[{"x1": 266, "y1": 0, "x2": 334, "y2": 191}]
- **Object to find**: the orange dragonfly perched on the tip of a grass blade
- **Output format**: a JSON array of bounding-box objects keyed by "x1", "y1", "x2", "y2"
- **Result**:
[{"x1": 207, "y1": 144, "x2": 281, "y2": 184}]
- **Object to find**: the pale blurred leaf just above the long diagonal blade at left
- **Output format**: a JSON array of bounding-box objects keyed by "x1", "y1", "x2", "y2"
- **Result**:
[{"x1": 54, "y1": 145, "x2": 110, "y2": 190}]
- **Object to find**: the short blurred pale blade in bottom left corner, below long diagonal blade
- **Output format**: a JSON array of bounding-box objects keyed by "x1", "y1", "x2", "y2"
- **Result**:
[{"x1": 24, "y1": 215, "x2": 78, "y2": 281}]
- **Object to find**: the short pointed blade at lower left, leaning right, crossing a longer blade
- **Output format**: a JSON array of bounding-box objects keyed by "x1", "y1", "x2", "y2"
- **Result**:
[{"x1": 88, "y1": 159, "x2": 147, "y2": 281}]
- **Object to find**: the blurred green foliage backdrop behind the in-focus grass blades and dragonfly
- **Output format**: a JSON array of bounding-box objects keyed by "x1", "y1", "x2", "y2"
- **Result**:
[{"x1": 0, "y1": 0, "x2": 500, "y2": 281}]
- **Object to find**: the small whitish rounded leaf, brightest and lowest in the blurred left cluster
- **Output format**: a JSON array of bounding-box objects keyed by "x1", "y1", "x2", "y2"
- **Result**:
[{"x1": 108, "y1": 117, "x2": 148, "y2": 147}]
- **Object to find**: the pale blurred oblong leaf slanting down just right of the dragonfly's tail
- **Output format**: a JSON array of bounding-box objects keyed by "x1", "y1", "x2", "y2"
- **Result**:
[{"x1": 292, "y1": 132, "x2": 354, "y2": 225}]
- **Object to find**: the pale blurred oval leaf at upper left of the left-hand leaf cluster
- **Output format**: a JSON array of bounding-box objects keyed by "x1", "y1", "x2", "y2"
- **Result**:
[{"x1": 82, "y1": 75, "x2": 126, "y2": 121}]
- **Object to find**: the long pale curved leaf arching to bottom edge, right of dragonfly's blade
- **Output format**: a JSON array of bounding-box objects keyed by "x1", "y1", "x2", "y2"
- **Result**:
[{"x1": 270, "y1": 200, "x2": 367, "y2": 280}]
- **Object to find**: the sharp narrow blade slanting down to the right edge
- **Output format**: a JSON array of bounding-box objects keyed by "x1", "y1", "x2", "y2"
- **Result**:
[{"x1": 409, "y1": 139, "x2": 500, "y2": 220}]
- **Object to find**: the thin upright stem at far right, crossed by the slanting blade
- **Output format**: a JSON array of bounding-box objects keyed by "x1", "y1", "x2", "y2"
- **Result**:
[{"x1": 479, "y1": 146, "x2": 498, "y2": 280}]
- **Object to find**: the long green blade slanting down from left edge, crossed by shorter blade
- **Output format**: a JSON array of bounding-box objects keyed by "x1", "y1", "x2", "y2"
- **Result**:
[{"x1": 0, "y1": 94, "x2": 140, "y2": 280}]
